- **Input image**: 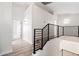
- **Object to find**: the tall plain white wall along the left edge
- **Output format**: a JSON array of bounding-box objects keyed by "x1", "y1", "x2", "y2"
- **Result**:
[{"x1": 0, "y1": 2, "x2": 12, "y2": 55}]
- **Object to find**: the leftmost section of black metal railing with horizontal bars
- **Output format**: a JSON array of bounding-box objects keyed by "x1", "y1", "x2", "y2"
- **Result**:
[{"x1": 33, "y1": 29, "x2": 42, "y2": 54}]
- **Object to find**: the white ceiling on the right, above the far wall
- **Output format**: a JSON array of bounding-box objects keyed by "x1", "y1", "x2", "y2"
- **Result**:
[{"x1": 46, "y1": 2, "x2": 79, "y2": 14}]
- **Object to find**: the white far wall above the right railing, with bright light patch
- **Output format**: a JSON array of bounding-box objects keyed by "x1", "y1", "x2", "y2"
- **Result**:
[{"x1": 57, "y1": 13, "x2": 79, "y2": 26}]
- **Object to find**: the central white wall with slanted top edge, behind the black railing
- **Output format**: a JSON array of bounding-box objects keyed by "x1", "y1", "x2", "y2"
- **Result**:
[{"x1": 32, "y1": 5, "x2": 53, "y2": 28}]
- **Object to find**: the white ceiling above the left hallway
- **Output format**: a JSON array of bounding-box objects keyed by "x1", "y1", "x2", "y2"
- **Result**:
[{"x1": 12, "y1": 2, "x2": 31, "y2": 20}]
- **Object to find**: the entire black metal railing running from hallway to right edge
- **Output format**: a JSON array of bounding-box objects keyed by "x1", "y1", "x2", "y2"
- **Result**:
[{"x1": 33, "y1": 23, "x2": 79, "y2": 54}]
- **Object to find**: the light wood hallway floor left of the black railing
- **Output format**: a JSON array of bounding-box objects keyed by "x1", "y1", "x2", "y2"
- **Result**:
[{"x1": 5, "y1": 40, "x2": 32, "y2": 56}]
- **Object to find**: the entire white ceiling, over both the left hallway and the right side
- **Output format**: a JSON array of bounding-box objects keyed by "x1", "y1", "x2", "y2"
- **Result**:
[{"x1": 12, "y1": 2, "x2": 79, "y2": 20}]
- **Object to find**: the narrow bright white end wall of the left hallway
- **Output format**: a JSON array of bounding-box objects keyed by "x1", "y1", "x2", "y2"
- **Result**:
[{"x1": 13, "y1": 20, "x2": 21, "y2": 40}]
